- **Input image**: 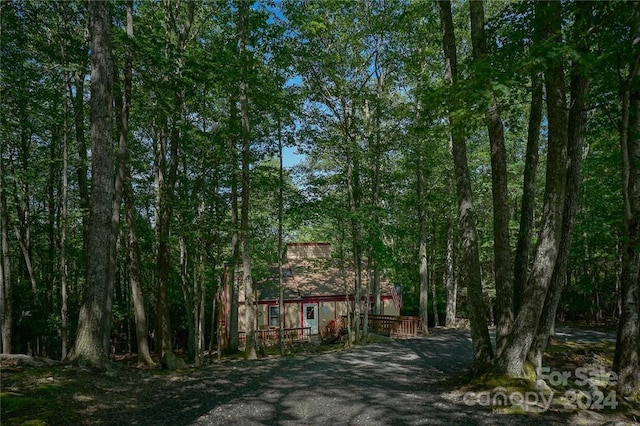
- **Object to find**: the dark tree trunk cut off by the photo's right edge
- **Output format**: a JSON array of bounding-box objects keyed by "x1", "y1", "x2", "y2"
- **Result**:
[{"x1": 613, "y1": 2, "x2": 640, "y2": 398}]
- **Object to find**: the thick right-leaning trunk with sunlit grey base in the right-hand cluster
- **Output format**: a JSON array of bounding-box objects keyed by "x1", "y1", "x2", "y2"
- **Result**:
[{"x1": 496, "y1": 1, "x2": 568, "y2": 376}]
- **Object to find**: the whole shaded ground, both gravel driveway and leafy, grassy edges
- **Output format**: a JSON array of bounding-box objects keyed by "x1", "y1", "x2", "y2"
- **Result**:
[{"x1": 0, "y1": 329, "x2": 640, "y2": 425}]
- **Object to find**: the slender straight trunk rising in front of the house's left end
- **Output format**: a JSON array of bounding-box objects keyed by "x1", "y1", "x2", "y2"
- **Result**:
[{"x1": 238, "y1": 0, "x2": 257, "y2": 359}]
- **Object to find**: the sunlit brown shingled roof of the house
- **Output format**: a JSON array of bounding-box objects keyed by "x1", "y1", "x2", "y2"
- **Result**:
[{"x1": 258, "y1": 258, "x2": 391, "y2": 300}]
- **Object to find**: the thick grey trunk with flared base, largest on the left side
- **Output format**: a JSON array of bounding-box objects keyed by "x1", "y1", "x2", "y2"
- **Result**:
[{"x1": 70, "y1": 1, "x2": 115, "y2": 367}]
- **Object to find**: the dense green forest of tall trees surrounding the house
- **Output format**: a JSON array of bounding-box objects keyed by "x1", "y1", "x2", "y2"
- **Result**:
[{"x1": 0, "y1": 0, "x2": 640, "y2": 395}]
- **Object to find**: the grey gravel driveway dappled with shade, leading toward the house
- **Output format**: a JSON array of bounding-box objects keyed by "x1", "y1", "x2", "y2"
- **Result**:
[{"x1": 100, "y1": 330, "x2": 624, "y2": 426}]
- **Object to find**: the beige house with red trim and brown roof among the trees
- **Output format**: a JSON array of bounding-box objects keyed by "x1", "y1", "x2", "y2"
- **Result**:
[{"x1": 224, "y1": 243, "x2": 401, "y2": 342}]
